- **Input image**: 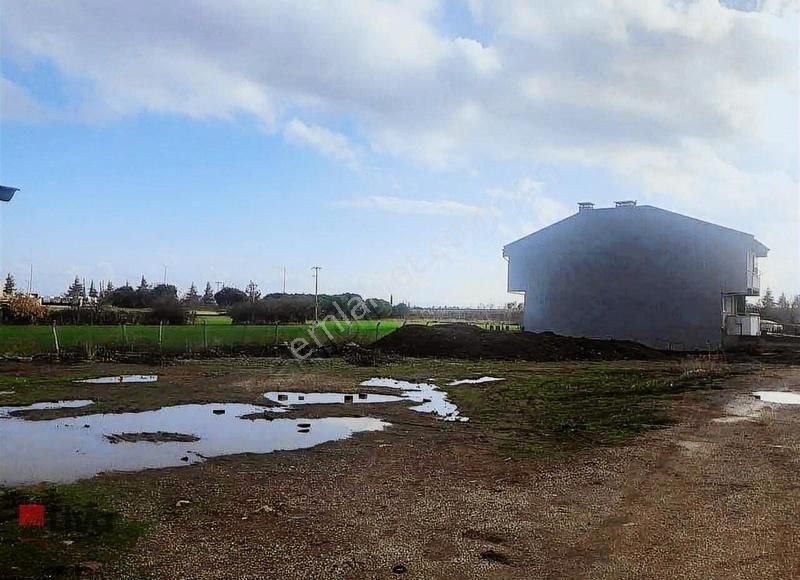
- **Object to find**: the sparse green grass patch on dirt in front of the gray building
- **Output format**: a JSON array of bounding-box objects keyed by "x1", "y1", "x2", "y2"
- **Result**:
[{"x1": 448, "y1": 363, "x2": 725, "y2": 456}]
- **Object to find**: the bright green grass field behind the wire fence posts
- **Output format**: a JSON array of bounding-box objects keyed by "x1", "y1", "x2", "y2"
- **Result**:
[{"x1": 0, "y1": 316, "x2": 403, "y2": 356}]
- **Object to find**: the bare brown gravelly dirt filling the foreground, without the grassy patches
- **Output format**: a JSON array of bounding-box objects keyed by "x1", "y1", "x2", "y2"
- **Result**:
[{"x1": 1, "y1": 362, "x2": 800, "y2": 579}]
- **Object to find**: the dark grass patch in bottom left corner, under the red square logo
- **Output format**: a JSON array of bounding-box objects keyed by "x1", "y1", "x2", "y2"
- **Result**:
[{"x1": 0, "y1": 481, "x2": 145, "y2": 578}]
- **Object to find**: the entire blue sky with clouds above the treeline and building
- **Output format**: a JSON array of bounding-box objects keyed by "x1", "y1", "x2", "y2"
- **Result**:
[{"x1": 0, "y1": 0, "x2": 800, "y2": 306}]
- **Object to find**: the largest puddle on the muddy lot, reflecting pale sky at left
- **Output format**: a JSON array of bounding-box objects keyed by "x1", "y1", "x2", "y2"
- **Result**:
[{"x1": 0, "y1": 401, "x2": 389, "y2": 486}]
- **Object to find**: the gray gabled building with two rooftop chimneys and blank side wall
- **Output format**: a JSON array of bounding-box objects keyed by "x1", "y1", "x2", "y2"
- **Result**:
[{"x1": 503, "y1": 201, "x2": 768, "y2": 350}]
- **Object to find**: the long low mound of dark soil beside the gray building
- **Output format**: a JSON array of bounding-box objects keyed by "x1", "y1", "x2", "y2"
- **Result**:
[{"x1": 372, "y1": 324, "x2": 667, "y2": 361}]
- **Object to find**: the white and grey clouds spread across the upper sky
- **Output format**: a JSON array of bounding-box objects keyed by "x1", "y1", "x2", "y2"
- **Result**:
[{"x1": 0, "y1": 0, "x2": 800, "y2": 290}]
